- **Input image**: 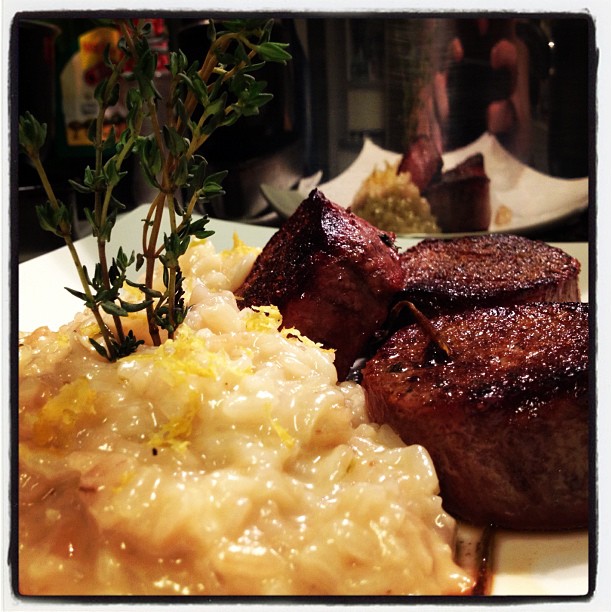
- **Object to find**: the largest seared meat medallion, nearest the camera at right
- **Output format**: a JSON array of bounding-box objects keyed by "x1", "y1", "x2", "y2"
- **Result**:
[{"x1": 362, "y1": 303, "x2": 589, "y2": 529}]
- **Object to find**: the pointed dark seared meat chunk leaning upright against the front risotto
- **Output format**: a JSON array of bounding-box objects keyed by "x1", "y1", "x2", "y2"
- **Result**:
[{"x1": 237, "y1": 190, "x2": 404, "y2": 380}]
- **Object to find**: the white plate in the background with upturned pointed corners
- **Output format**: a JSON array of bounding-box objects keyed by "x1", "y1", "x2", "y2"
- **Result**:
[{"x1": 262, "y1": 133, "x2": 589, "y2": 234}]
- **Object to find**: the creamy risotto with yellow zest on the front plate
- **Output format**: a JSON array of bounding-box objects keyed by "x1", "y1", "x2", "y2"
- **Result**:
[{"x1": 19, "y1": 233, "x2": 472, "y2": 595}]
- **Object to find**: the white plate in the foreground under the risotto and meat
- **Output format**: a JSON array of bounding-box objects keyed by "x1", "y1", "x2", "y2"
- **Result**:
[{"x1": 18, "y1": 208, "x2": 589, "y2": 596}]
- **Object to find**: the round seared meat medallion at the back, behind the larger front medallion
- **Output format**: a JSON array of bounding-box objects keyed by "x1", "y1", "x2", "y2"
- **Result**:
[{"x1": 401, "y1": 234, "x2": 580, "y2": 315}]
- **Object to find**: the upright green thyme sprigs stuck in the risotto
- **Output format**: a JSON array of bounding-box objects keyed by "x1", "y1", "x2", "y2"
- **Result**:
[{"x1": 19, "y1": 19, "x2": 291, "y2": 361}]
